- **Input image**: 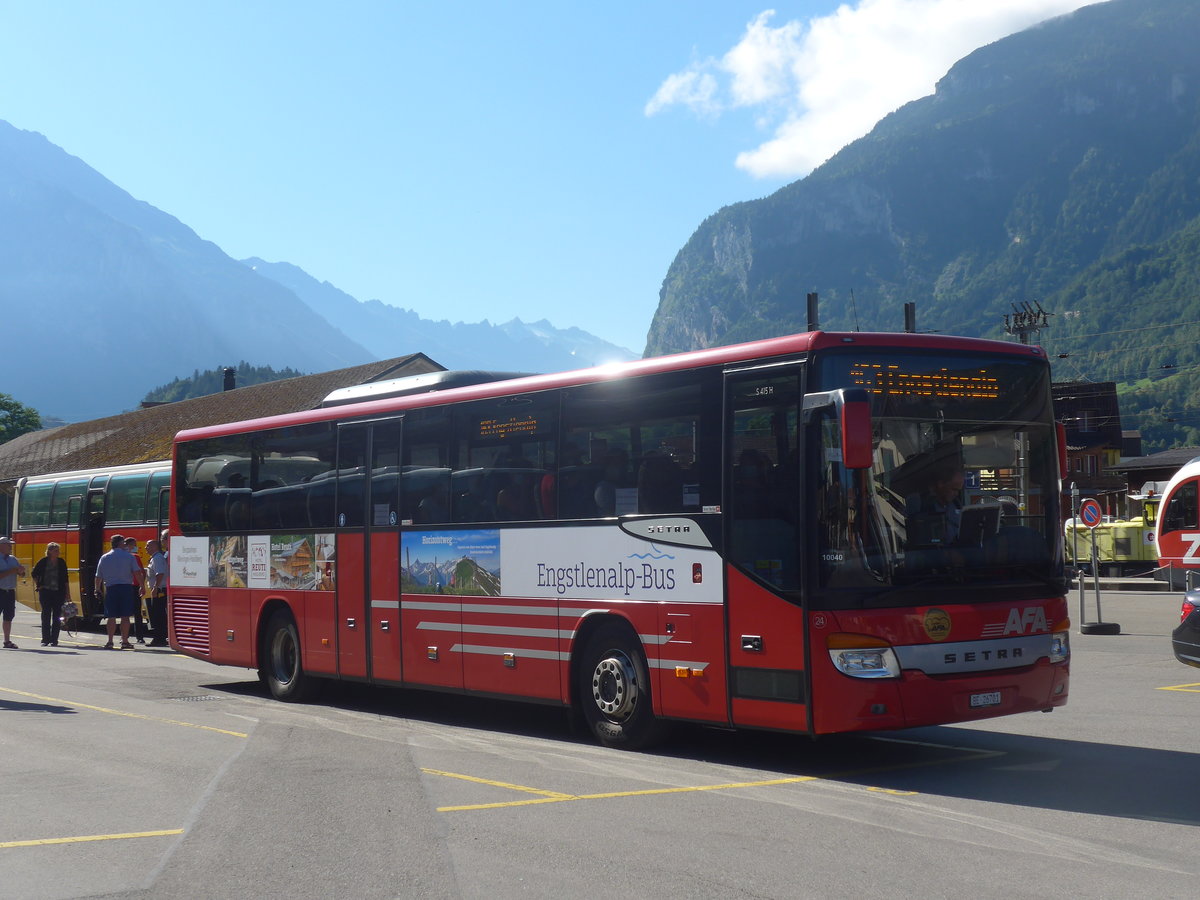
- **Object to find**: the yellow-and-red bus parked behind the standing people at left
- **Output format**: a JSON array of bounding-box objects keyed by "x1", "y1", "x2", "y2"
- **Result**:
[{"x1": 13, "y1": 460, "x2": 170, "y2": 619}]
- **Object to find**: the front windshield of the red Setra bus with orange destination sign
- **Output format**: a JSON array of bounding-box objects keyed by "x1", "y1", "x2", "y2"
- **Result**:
[{"x1": 810, "y1": 352, "x2": 1061, "y2": 606}]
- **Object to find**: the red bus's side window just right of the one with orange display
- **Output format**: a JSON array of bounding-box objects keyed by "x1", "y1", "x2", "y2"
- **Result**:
[{"x1": 556, "y1": 373, "x2": 719, "y2": 518}]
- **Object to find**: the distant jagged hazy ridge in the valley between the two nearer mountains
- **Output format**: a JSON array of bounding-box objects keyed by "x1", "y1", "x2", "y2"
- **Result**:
[{"x1": 242, "y1": 257, "x2": 637, "y2": 372}]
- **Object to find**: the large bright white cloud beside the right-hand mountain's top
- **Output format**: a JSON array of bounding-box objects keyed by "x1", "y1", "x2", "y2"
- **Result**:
[{"x1": 646, "y1": 0, "x2": 1093, "y2": 178}]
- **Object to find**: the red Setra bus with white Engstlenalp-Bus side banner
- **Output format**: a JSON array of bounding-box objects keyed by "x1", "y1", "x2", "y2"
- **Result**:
[{"x1": 170, "y1": 332, "x2": 1069, "y2": 748}]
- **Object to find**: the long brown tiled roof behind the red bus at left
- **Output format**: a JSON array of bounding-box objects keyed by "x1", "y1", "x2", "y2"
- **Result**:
[{"x1": 0, "y1": 353, "x2": 444, "y2": 506}]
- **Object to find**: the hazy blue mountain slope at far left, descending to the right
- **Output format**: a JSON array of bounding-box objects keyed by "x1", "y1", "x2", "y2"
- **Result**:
[{"x1": 0, "y1": 121, "x2": 372, "y2": 420}]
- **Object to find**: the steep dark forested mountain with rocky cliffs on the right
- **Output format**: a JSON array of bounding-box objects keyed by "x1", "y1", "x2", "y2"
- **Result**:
[{"x1": 647, "y1": 0, "x2": 1200, "y2": 446}]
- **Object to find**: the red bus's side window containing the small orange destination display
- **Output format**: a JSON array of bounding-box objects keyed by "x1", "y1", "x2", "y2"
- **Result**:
[{"x1": 450, "y1": 395, "x2": 558, "y2": 522}]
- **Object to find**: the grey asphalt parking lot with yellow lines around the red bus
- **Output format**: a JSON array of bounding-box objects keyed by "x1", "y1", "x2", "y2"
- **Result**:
[{"x1": 0, "y1": 593, "x2": 1200, "y2": 898}]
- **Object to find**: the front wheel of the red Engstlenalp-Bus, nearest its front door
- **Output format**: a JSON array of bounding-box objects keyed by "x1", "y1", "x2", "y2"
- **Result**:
[{"x1": 578, "y1": 625, "x2": 666, "y2": 750}]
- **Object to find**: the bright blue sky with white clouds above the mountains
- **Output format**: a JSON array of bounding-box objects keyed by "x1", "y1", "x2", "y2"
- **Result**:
[{"x1": 0, "y1": 0, "x2": 1086, "y2": 353}]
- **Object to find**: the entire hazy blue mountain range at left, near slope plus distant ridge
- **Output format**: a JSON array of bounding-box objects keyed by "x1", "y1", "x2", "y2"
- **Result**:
[{"x1": 0, "y1": 121, "x2": 636, "y2": 421}]
